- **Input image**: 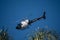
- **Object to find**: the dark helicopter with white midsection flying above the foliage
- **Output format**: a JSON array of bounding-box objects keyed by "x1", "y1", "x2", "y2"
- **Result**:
[{"x1": 16, "y1": 11, "x2": 46, "y2": 30}]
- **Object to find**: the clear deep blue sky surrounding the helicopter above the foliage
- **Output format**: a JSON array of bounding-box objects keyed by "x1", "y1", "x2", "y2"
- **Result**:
[{"x1": 0, "y1": 0, "x2": 60, "y2": 40}]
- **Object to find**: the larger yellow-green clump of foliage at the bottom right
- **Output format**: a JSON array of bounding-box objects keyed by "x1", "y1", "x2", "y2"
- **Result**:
[{"x1": 29, "y1": 29, "x2": 60, "y2": 40}]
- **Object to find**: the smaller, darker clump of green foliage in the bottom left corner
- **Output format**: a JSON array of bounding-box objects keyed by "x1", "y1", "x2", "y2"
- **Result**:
[{"x1": 0, "y1": 27, "x2": 11, "y2": 40}]
